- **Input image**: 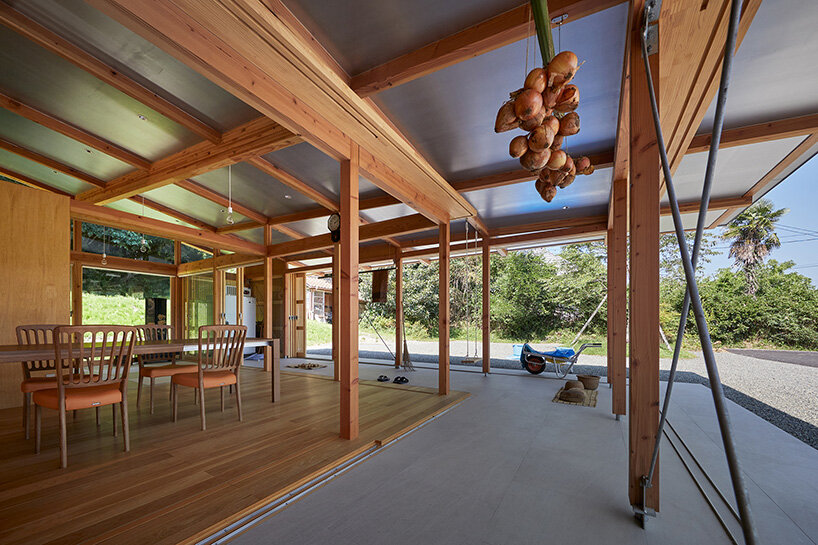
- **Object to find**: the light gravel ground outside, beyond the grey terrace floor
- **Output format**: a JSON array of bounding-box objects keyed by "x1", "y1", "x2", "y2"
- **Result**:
[{"x1": 309, "y1": 339, "x2": 818, "y2": 449}]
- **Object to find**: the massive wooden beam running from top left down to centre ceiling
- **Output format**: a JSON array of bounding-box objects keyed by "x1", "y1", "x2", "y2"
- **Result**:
[{"x1": 89, "y1": 0, "x2": 475, "y2": 222}]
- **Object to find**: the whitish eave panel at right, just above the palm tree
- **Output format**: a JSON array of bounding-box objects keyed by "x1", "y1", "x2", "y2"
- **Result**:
[{"x1": 668, "y1": 136, "x2": 805, "y2": 204}]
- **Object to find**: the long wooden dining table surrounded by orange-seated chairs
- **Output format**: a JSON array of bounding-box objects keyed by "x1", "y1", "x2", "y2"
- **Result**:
[{"x1": 0, "y1": 338, "x2": 281, "y2": 403}]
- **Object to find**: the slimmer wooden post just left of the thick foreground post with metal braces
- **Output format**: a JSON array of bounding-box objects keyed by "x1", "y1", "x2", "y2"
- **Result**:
[{"x1": 608, "y1": 179, "x2": 628, "y2": 416}]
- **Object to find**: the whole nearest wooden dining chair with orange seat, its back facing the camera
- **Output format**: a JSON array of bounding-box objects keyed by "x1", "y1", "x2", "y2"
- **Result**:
[{"x1": 33, "y1": 325, "x2": 136, "y2": 467}]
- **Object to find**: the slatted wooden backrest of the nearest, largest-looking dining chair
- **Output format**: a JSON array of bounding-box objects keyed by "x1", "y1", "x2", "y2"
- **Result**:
[{"x1": 54, "y1": 325, "x2": 137, "y2": 392}]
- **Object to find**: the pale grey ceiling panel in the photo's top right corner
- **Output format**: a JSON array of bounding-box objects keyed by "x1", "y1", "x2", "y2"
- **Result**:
[{"x1": 699, "y1": 0, "x2": 818, "y2": 132}]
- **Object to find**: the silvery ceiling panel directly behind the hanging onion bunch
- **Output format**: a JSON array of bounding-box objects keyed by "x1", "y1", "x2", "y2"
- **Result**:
[{"x1": 373, "y1": 4, "x2": 627, "y2": 182}]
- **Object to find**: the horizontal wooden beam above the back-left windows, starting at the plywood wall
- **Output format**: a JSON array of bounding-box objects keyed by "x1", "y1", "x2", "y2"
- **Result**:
[{"x1": 71, "y1": 200, "x2": 264, "y2": 255}]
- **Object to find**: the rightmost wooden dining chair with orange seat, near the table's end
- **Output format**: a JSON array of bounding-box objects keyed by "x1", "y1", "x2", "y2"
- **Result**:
[{"x1": 171, "y1": 325, "x2": 247, "y2": 431}]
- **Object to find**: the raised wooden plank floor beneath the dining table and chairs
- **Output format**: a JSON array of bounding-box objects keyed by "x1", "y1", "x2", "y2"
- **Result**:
[{"x1": 0, "y1": 368, "x2": 468, "y2": 545}]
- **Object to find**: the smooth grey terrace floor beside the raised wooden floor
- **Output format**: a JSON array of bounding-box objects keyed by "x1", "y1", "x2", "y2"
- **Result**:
[{"x1": 226, "y1": 360, "x2": 818, "y2": 545}]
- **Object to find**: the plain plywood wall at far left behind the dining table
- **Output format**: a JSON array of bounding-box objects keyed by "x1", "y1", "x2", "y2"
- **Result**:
[{"x1": 0, "y1": 183, "x2": 71, "y2": 408}]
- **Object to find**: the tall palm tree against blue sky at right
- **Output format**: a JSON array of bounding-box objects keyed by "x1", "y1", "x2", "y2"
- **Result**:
[{"x1": 722, "y1": 199, "x2": 789, "y2": 296}]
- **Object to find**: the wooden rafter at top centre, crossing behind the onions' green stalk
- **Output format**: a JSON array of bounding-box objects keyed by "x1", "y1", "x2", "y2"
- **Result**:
[{"x1": 350, "y1": 0, "x2": 622, "y2": 96}]
